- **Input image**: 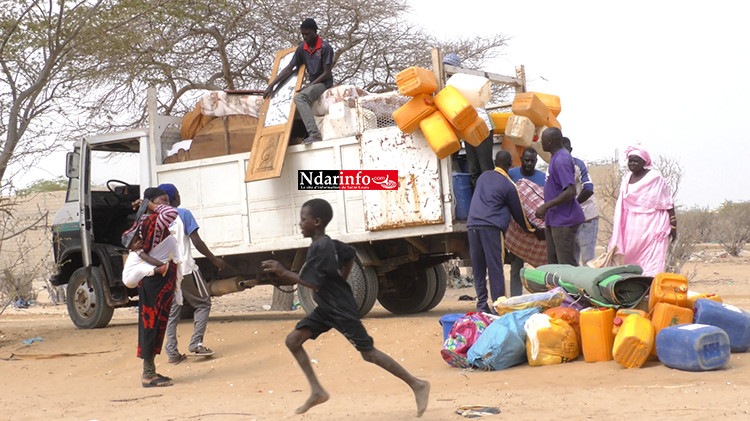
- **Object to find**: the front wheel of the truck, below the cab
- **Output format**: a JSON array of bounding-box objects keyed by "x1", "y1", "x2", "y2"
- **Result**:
[{"x1": 66, "y1": 267, "x2": 115, "y2": 329}]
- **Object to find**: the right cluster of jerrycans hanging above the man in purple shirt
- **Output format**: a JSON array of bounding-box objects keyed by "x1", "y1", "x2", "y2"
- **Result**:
[{"x1": 490, "y1": 92, "x2": 562, "y2": 165}]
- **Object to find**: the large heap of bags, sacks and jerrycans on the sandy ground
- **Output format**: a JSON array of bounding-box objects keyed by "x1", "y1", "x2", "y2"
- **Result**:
[{"x1": 441, "y1": 265, "x2": 750, "y2": 371}]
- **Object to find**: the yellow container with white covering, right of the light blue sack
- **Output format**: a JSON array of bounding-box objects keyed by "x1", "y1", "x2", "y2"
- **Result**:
[{"x1": 524, "y1": 314, "x2": 579, "y2": 367}]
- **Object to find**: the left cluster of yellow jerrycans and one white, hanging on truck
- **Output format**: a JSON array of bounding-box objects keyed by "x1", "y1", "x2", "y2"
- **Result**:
[{"x1": 393, "y1": 67, "x2": 490, "y2": 159}]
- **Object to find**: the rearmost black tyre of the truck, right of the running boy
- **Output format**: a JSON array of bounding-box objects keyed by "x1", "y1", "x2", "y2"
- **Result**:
[{"x1": 378, "y1": 264, "x2": 437, "y2": 314}]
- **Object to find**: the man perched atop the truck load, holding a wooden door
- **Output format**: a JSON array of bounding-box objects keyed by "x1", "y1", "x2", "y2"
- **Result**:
[{"x1": 263, "y1": 18, "x2": 333, "y2": 143}]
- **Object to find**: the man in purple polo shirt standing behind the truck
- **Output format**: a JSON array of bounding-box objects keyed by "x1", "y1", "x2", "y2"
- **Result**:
[{"x1": 535, "y1": 127, "x2": 586, "y2": 266}]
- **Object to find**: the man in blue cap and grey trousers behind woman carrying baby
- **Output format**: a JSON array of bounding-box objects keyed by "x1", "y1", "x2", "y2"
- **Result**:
[{"x1": 159, "y1": 184, "x2": 226, "y2": 364}]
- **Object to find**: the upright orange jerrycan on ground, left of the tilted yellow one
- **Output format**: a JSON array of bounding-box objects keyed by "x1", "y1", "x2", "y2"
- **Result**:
[{"x1": 580, "y1": 308, "x2": 615, "y2": 363}]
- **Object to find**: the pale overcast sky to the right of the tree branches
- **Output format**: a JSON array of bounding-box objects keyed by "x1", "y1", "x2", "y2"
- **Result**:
[{"x1": 410, "y1": 0, "x2": 750, "y2": 208}]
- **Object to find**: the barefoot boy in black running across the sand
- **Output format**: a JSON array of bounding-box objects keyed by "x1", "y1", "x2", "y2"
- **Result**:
[{"x1": 263, "y1": 199, "x2": 430, "y2": 417}]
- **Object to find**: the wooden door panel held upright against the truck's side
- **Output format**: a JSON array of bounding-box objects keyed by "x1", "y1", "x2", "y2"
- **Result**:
[{"x1": 245, "y1": 47, "x2": 305, "y2": 183}]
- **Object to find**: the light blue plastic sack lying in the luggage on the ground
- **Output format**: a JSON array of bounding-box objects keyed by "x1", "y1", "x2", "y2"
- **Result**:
[{"x1": 467, "y1": 307, "x2": 540, "y2": 370}]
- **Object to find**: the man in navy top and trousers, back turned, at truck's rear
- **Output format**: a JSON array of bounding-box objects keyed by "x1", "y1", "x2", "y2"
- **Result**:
[{"x1": 466, "y1": 151, "x2": 538, "y2": 312}]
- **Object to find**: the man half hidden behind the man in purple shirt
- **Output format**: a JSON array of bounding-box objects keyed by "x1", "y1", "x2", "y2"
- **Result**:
[{"x1": 563, "y1": 137, "x2": 599, "y2": 265}]
